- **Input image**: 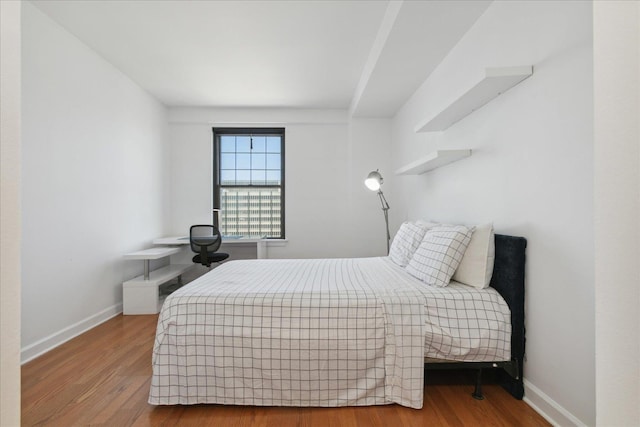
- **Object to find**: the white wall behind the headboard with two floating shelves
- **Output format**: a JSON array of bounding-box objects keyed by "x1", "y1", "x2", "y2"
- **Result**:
[{"x1": 393, "y1": 1, "x2": 595, "y2": 425}]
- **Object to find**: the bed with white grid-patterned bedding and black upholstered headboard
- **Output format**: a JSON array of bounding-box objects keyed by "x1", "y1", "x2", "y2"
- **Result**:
[{"x1": 149, "y1": 231, "x2": 526, "y2": 408}]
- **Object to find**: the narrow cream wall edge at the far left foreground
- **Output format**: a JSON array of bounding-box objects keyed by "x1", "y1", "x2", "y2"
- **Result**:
[{"x1": 0, "y1": 1, "x2": 21, "y2": 426}]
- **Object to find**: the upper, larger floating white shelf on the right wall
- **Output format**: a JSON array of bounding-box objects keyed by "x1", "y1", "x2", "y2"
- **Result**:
[{"x1": 415, "y1": 65, "x2": 533, "y2": 132}]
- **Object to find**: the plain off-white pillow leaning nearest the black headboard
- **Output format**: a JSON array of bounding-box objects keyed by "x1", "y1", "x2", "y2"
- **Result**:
[{"x1": 452, "y1": 223, "x2": 496, "y2": 289}]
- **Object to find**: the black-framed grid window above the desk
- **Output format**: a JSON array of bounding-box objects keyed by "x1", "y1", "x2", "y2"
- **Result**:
[{"x1": 213, "y1": 128, "x2": 284, "y2": 239}]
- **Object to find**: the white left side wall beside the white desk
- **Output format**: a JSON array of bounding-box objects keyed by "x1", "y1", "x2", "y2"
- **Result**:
[{"x1": 22, "y1": 3, "x2": 168, "y2": 359}]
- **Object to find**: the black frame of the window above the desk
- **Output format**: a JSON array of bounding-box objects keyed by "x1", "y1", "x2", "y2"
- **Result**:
[{"x1": 211, "y1": 127, "x2": 286, "y2": 240}]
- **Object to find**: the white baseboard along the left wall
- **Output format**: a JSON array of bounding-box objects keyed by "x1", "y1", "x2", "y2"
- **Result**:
[{"x1": 20, "y1": 303, "x2": 122, "y2": 365}]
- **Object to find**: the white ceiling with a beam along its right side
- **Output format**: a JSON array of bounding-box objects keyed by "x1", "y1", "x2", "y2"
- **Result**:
[{"x1": 32, "y1": 0, "x2": 490, "y2": 117}]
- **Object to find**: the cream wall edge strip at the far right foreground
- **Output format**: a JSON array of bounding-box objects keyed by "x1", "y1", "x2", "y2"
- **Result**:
[{"x1": 594, "y1": 1, "x2": 640, "y2": 426}]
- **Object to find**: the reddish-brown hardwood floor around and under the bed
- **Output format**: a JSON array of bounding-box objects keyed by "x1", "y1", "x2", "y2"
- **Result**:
[{"x1": 22, "y1": 315, "x2": 549, "y2": 427}]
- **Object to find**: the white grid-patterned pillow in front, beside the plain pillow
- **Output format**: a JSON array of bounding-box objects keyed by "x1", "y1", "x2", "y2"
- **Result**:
[{"x1": 406, "y1": 225, "x2": 473, "y2": 287}]
